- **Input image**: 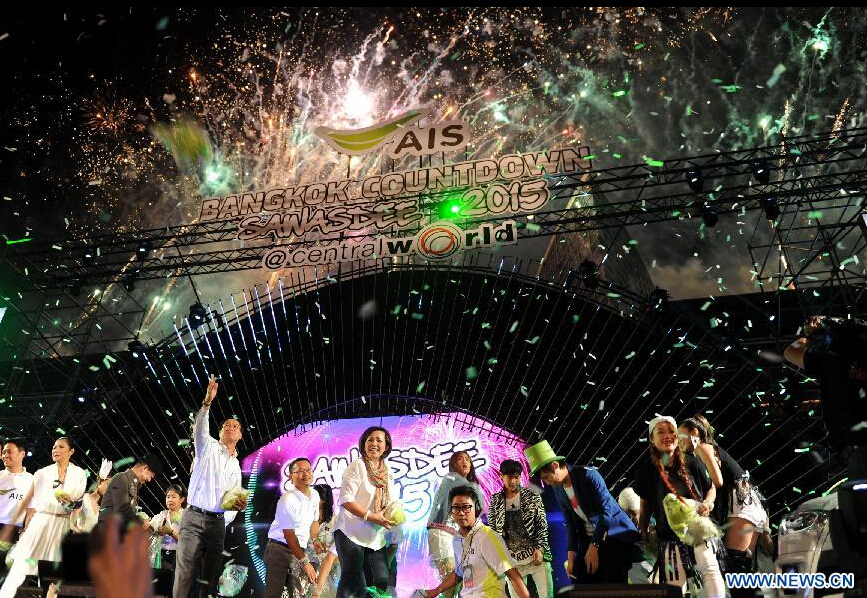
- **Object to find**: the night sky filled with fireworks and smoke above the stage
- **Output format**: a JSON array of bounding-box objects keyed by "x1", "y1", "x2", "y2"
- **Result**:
[{"x1": 0, "y1": 8, "x2": 867, "y2": 324}]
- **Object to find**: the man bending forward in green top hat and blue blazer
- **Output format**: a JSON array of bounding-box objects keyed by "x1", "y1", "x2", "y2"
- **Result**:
[{"x1": 524, "y1": 440, "x2": 641, "y2": 584}]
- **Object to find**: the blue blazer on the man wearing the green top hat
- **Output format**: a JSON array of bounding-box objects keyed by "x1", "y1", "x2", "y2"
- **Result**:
[{"x1": 554, "y1": 465, "x2": 641, "y2": 555}]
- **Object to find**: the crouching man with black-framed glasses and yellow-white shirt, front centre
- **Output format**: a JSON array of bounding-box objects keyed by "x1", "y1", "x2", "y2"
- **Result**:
[{"x1": 424, "y1": 486, "x2": 530, "y2": 598}]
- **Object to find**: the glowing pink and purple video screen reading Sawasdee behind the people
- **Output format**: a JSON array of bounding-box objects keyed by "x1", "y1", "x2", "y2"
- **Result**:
[{"x1": 243, "y1": 413, "x2": 528, "y2": 598}]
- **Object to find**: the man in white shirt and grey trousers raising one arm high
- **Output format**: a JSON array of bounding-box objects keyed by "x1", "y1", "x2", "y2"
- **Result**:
[{"x1": 172, "y1": 376, "x2": 247, "y2": 598}]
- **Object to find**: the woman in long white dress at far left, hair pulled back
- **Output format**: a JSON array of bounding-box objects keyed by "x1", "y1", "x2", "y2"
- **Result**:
[{"x1": 0, "y1": 437, "x2": 87, "y2": 598}]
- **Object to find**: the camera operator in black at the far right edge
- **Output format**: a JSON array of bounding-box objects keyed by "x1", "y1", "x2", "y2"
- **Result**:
[{"x1": 784, "y1": 316, "x2": 867, "y2": 479}]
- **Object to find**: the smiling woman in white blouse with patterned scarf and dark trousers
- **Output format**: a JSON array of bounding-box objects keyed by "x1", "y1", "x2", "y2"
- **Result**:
[{"x1": 334, "y1": 426, "x2": 398, "y2": 598}]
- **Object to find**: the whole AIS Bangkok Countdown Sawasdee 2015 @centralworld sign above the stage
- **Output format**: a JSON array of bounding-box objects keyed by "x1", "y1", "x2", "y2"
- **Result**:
[{"x1": 193, "y1": 108, "x2": 590, "y2": 270}]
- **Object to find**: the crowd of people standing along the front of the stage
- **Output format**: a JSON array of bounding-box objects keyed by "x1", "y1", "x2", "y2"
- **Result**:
[{"x1": 0, "y1": 377, "x2": 769, "y2": 598}]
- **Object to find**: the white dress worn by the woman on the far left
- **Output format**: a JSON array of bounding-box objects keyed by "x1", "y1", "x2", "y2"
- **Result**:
[{"x1": 0, "y1": 463, "x2": 87, "y2": 598}]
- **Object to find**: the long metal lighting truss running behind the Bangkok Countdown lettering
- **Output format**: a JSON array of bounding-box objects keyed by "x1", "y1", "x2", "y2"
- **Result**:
[{"x1": 1, "y1": 128, "x2": 867, "y2": 289}]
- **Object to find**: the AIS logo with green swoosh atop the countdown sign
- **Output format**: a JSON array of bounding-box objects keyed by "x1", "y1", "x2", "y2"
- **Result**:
[{"x1": 313, "y1": 108, "x2": 470, "y2": 160}]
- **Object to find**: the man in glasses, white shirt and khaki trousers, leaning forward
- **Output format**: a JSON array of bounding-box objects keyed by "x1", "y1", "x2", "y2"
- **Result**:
[{"x1": 262, "y1": 457, "x2": 319, "y2": 598}]
